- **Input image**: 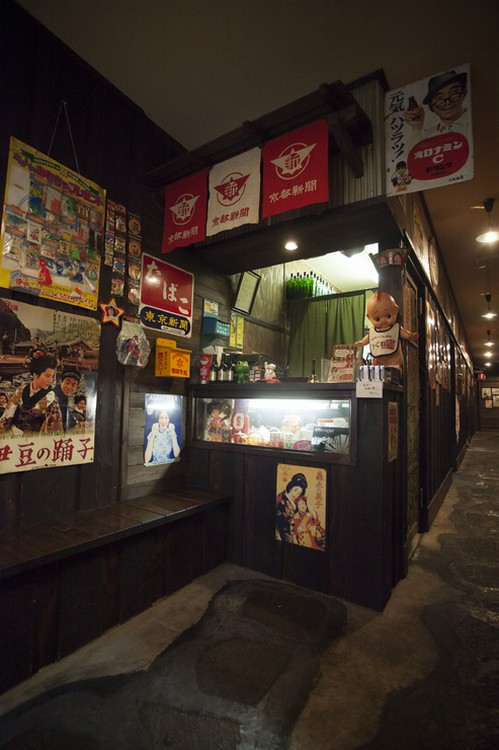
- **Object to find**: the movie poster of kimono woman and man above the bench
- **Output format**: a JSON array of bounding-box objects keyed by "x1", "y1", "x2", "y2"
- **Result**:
[{"x1": 0, "y1": 299, "x2": 101, "y2": 474}]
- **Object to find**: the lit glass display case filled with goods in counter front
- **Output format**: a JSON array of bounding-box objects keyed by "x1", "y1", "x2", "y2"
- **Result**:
[{"x1": 192, "y1": 384, "x2": 353, "y2": 462}]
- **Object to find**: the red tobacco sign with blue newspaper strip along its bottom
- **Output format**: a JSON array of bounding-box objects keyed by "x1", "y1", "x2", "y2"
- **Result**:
[{"x1": 139, "y1": 253, "x2": 194, "y2": 338}]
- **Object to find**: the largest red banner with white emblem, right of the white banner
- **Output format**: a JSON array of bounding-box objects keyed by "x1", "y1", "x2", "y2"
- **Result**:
[{"x1": 262, "y1": 120, "x2": 329, "y2": 219}]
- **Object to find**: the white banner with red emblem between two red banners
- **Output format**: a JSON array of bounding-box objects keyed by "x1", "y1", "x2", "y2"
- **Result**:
[{"x1": 206, "y1": 148, "x2": 261, "y2": 237}]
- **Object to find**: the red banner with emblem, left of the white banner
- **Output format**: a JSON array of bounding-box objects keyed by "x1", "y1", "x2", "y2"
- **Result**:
[{"x1": 161, "y1": 169, "x2": 208, "y2": 253}]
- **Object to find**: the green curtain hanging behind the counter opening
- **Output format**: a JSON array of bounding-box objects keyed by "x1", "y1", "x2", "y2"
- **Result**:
[{"x1": 288, "y1": 292, "x2": 365, "y2": 378}]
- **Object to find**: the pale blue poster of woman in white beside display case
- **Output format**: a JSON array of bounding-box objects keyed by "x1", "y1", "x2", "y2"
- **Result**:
[{"x1": 144, "y1": 393, "x2": 182, "y2": 466}]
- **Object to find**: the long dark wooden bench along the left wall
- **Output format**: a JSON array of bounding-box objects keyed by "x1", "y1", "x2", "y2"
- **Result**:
[{"x1": 0, "y1": 489, "x2": 232, "y2": 692}]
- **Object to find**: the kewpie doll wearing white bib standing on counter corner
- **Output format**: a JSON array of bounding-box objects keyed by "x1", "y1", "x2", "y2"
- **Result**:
[{"x1": 354, "y1": 290, "x2": 418, "y2": 371}]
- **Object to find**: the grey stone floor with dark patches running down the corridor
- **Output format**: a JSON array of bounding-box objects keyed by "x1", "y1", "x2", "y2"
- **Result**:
[{"x1": 0, "y1": 431, "x2": 499, "y2": 750}]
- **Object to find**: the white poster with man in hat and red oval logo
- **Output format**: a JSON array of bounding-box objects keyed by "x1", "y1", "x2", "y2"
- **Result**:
[{"x1": 385, "y1": 65, "x2": 474, "y2": 195}]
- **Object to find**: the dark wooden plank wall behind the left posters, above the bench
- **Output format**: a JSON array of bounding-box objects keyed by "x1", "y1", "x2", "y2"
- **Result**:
[{"x1": 0, "y1": 0, "x2": 186, "y2": 529}]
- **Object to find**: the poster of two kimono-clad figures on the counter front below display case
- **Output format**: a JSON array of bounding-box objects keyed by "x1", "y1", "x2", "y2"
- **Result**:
[{"x1": 275, "y1": 464, "x2": 327, "y2": 552}]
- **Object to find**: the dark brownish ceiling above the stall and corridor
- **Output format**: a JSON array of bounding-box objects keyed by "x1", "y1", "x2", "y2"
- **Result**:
[{"x1": 14, "y1": 0, "x2": 499, "y2": 375}]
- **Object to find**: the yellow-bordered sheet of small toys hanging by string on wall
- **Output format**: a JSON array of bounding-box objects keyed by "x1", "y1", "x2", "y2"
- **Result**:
[{"x1": 0, "y1": 138, "x2": 106, "y2": 310}]
